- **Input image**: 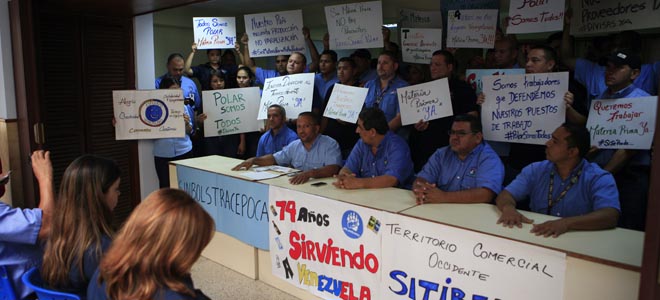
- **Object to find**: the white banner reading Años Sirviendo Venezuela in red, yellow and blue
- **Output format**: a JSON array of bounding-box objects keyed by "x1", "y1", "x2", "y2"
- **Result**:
[{"x1": 269, "y1": 186, "x2": 382, "y2": 299}]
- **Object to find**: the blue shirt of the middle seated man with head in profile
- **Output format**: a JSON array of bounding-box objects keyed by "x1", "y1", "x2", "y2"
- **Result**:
[{"x1": 344, "y1": 131, "x2": 414, "y2": 188}]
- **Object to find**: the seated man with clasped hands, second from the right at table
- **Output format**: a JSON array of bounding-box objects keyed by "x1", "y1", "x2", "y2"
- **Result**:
[{"x1": 413, "y1": 115, "x2": 504, "y2": 204}]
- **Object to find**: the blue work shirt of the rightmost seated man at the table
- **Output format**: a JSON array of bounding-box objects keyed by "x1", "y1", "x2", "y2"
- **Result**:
[{"x1": 504, "y1": 159, "x2": 621, "y2": 218}]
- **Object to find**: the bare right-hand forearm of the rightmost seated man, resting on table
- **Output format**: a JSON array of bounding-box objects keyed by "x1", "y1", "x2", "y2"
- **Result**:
[{"x1": 530, "y1": 207, "x2": 619, "y2": 237}]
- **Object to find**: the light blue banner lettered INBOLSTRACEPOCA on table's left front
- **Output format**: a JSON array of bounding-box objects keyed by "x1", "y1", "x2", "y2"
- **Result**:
[{"x1": 176, "y1": 165, "x2": 270, "y2": 250}]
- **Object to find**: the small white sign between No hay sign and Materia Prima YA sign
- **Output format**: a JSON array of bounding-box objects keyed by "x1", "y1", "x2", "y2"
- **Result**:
[{"x1": 401, "y1": 28, "x2": 442, "y2": 64}]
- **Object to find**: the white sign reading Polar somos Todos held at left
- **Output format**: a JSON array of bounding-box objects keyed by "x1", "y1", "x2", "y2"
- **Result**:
[{"x1": 202, "y1": 87, "x2": 261, "y2": 137}]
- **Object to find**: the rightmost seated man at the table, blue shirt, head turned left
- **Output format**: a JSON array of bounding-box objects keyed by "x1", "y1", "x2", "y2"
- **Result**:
[{"x1": 495, "y1": 123, "x2": 620, "y2": 237}]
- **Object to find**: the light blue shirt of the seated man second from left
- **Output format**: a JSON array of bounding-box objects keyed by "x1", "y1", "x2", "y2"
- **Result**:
[{"x1": 273, "y1": 135, "x2": 341, "y2": 171}]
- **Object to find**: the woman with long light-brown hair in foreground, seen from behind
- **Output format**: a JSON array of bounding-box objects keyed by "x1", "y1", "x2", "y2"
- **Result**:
[{"x1": 87, "y1": 189, "x2": 215, "y2": 300}]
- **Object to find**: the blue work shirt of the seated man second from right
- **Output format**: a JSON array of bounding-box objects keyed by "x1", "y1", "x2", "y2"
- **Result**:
[{"x1": 417, "y1": 142, "x2": 504, "y2": 194}]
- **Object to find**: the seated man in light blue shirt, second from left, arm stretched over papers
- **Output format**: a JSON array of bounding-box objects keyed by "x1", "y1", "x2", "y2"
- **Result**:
[{"x1": 232, "y1": 112, "x2": 341, "y2": 184}]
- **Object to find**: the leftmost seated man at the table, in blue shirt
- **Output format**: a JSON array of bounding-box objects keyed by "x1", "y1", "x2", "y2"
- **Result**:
[{"x1": 257, "y1": 104, "x2": 298, "y2": 157}]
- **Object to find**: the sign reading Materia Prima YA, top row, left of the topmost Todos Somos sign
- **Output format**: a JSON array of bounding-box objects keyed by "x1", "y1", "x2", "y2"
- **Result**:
[{"x1": 447, "y1": 9, "x2": 497, "y2": 48}]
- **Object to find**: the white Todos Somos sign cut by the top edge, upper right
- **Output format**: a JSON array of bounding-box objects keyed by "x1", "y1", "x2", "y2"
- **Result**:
[{"x1": 506, "y1": 0, "x2": 566, "y2": 34}]
